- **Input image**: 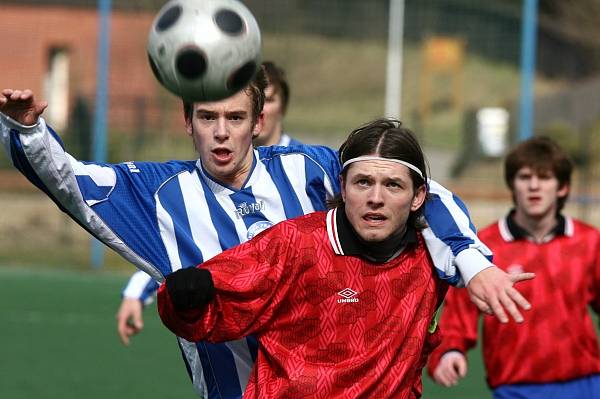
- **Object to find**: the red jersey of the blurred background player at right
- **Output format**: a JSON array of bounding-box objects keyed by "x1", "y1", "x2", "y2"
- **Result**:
[{"x1": 428, "y1": 215, "x2": 600, "y2": 388}]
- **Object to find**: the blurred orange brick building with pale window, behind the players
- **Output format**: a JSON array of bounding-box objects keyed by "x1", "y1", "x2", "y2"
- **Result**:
[{"x1": 0, "y1": 0, "x2": 180, "y2": 134}]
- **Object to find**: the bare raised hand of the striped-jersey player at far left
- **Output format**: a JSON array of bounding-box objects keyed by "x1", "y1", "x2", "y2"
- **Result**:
[{"x1": 0, "y1": 89, "x2": 48, "y2": 126}]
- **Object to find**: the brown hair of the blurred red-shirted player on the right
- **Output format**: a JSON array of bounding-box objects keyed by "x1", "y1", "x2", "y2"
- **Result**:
[{"x1": 504, "y1": 136, "x2": 573, "y2": 211}]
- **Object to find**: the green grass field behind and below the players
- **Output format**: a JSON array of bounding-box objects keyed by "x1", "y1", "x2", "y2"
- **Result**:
[{"x1": 0, "y1": 267, "x2": 490, "y2": 399}]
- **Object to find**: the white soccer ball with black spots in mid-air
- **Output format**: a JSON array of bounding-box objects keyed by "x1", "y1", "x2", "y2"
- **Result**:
[{"x1": 147, "y1": 0, "x2": 261, "y2": 102}]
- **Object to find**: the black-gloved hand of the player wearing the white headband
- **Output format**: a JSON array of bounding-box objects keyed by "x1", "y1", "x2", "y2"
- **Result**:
[{"x1": 165, "y1": 267, "x2": 215, "y2": 310}]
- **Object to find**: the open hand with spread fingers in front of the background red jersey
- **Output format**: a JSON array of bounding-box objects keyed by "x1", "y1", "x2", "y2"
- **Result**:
[{"x1": 467, "y1": 267, "x2": 535, "y2": 323}]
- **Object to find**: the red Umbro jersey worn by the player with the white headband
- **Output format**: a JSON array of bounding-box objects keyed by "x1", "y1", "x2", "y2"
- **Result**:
[{"x1": 158, "y1": 210, "x2": 447, "y2": 399}]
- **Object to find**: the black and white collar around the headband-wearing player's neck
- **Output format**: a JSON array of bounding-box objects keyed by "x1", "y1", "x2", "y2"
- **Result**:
[{"x1": 326, "y1": 205, "x2": 419, "y2": 263}]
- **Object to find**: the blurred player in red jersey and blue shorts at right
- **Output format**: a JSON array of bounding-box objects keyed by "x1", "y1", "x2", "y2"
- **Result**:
[{"x1": 428, "y1": 138, "x2": 600, "y2": 399}]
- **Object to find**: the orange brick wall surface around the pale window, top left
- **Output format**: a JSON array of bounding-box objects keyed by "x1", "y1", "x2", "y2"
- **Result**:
[{"x1": 0, "y1": 4, "x2": 176, "y2": 127}]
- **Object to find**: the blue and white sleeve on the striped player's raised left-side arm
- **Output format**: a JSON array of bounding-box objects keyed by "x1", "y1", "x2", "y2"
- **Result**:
[{"x1": 0, "y1": 113, "x2": 176, "y2": 281}]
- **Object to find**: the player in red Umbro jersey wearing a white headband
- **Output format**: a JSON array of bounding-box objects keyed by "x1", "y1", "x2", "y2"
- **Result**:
[{"x1": 158, "y1": 120, "x2": 524, "y2": 398}]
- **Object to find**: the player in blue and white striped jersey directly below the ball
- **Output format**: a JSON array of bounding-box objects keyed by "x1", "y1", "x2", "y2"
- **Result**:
[{"x1": 0, "y1": 71, "x2": 527, "y2": 398}]
